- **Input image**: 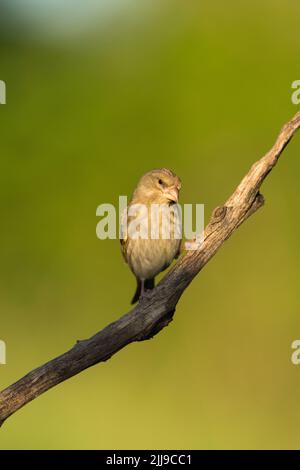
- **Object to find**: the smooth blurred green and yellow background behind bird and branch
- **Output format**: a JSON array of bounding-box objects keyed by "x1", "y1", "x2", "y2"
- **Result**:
[{"x1": 0, "y1": 0, "x2": 300, "y2": 449}]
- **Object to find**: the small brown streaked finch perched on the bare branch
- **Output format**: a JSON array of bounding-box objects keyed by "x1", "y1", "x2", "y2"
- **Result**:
[{"x1": 121, "y1": 168, "x2": 181, "y2": 304}]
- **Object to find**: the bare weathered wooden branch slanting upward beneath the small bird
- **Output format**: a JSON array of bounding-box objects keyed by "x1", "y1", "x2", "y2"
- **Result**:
[{"x1": 0, "y1": 112, "x2": 300, "y2": 426}]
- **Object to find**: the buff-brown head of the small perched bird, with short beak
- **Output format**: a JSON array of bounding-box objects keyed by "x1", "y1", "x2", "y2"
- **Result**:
[{"x1": 134, "y1": 168, "x2": 181, "y2": 204}]
